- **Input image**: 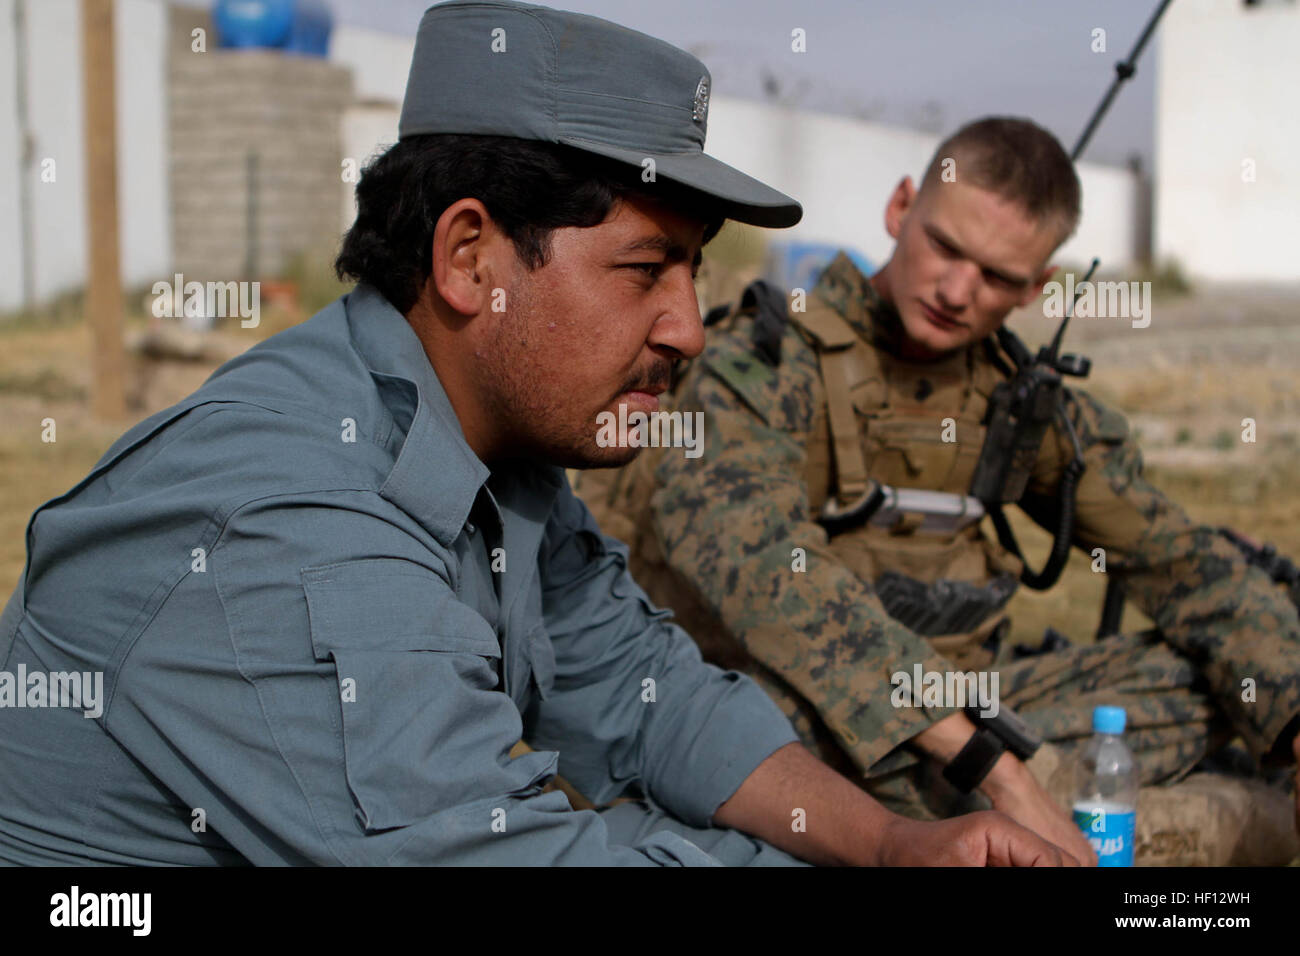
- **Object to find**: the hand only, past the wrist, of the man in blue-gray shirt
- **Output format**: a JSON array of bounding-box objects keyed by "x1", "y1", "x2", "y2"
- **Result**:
[{"x1": 878, "y1": 810, "x2": 1087, "y2": 866}]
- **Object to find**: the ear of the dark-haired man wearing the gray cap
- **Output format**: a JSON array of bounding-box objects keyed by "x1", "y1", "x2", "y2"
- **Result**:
[{"x1": 429, "y1": 199, "x2": 506, "y2": 316}]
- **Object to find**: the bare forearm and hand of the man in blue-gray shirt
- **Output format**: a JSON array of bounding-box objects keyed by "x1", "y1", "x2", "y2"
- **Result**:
[{"x1": 714, "y1": 744, "x2": 1087, "y2": 866}]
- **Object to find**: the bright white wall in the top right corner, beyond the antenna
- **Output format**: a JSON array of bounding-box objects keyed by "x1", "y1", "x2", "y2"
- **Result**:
[{"x1": 1154, "y1": 0, "x2": 1300, "y2": 281}]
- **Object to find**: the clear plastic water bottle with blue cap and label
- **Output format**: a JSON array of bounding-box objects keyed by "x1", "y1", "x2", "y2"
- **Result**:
[{"x1": 1074, "y1": 708, "x2": 1138, "y2": 866}]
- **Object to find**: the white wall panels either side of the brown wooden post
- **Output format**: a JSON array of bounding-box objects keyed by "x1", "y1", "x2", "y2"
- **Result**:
[{"x1": 0, "y1": 0, "x2": 172, "y2": 310}]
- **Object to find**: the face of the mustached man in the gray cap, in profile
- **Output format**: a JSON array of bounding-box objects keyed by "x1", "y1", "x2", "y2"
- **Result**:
[{"x1": 491, "y1": 193, "x2": 705, "y2": 468}]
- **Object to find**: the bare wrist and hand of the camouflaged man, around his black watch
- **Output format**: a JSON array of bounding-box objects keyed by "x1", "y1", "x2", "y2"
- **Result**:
[{"x1": 914, "y1": 711, "x2": 1097, "y2": 866}]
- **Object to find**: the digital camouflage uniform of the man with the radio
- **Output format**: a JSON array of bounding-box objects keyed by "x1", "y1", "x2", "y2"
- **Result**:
[{"x1": 579, "y1": 255, "x2": 1300, "y2": 868}]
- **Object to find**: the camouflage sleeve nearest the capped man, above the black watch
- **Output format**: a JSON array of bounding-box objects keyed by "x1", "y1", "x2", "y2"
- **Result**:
[{"x1": 651, "y1": 325, "x2": 953, "y2": 771}]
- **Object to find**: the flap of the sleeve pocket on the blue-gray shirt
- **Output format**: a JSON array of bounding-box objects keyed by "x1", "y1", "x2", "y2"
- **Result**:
[{"x1": 302, "y1": 558, "x2": 501, "y2": 661}]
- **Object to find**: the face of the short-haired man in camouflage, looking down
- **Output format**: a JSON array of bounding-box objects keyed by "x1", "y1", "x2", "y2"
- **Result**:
[{"x1": 885, "y1": 179, "x2": 1058, "y2": 358}]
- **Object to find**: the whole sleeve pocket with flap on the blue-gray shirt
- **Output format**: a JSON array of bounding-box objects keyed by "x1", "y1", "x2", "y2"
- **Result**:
[{"x1": 302, "y1": 558, "x2": 501, "y2": 831}]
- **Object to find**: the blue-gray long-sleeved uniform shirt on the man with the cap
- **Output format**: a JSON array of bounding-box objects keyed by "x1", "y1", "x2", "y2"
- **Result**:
[{"x1": 0, "y1": 285, "x2": 796, "y2": 865}]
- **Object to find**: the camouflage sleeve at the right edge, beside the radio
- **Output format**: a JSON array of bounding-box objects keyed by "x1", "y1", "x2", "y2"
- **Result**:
[{"x1": 1023, "y1": 390, "x2": 1300, "y2": 757}]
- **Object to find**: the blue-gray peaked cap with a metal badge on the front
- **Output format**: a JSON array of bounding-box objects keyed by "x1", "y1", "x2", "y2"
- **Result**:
[{"x1": 398, "y1": 0, "x2": 803, "y2": 226}]
